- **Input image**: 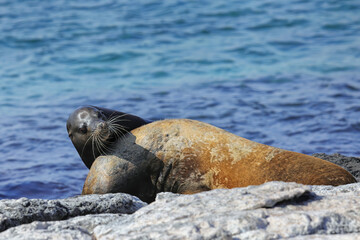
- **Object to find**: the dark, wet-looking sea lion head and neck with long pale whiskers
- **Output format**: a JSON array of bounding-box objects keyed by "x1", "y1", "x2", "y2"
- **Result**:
[{"x1": 66, "y1": 106, "x2": 150, "y2": 168}]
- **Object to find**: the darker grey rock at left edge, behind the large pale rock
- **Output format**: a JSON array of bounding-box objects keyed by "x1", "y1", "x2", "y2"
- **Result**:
[{"x1": 0, "y1": 193, "x2": 147, "y2": 231}]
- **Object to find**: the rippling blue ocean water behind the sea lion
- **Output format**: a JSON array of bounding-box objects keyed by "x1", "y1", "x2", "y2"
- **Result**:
[{"x1": 0, "y1": 0, "x2": 360, "y2": 199}]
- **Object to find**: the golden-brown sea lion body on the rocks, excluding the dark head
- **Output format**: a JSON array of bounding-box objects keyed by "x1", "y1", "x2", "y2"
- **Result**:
[{"x1": 82, "y1": 119, "x2": 356, "y2": 202}]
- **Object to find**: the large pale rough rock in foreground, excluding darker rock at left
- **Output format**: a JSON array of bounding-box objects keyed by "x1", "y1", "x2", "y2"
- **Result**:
[{"x1": 0, "y1": 182, "x2": 360, "y2": 239}]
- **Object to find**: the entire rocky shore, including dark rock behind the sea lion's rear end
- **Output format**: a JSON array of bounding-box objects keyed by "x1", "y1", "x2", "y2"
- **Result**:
[{"x1": 0, "y1": 154, "x2": 360, "y2": 239}]
